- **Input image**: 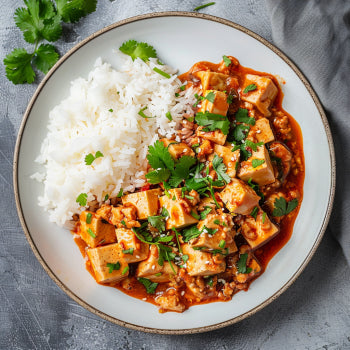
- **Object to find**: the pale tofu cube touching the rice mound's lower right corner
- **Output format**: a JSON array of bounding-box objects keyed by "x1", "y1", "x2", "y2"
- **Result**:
[{"x1": 122, "y1": 188, "x2": 161, "y2": 220}]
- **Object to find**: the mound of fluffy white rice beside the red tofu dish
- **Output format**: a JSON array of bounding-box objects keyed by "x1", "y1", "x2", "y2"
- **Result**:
[{"x1": 32, "y1": 56, "x2": 195, "y2": 226}]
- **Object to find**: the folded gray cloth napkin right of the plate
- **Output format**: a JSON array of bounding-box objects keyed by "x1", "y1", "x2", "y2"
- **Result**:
[{"x1": 266, "y1": 0, "x2": 350, "y2": 264}]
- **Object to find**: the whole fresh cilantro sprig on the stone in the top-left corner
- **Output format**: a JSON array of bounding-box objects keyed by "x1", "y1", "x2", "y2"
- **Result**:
[{"x1": 3, "y1": 0, "x2": 97, "y2": 84}]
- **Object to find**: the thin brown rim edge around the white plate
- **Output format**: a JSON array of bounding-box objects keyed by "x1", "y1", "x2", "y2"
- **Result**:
[{"x1": 13, "y1": 11, "x2": 336, "y2": 334}]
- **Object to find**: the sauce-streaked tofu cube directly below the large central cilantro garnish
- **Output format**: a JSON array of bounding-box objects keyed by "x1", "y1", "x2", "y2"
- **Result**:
[{"x1": 159, "y1": 188, "x2": 198, "y2": 230}]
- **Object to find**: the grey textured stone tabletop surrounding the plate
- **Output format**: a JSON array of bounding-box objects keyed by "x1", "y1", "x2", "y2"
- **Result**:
[{"x1": 0, "y1": 0, "x2": 350, "y2": 350}]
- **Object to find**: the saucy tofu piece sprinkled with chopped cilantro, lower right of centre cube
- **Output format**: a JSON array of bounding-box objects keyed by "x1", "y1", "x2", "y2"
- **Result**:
[{"x1": 191, "y1": 212, "x2": 237, "y2": 254}]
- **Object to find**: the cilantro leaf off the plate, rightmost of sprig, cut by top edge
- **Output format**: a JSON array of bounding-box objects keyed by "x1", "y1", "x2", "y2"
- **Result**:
[{"x1": 56, "y1": 0, "x2": 97, "y2": 23}]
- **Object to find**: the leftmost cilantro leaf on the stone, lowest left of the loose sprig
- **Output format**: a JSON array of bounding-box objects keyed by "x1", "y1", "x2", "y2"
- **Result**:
[{"x1": 4, "y1": 49, "x2": 35, "y2": 84}]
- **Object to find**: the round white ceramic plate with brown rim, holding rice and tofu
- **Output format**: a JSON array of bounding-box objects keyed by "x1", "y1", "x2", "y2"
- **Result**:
[{"x1": 14, "y1": 12, "x2": 335, "y2": 333}]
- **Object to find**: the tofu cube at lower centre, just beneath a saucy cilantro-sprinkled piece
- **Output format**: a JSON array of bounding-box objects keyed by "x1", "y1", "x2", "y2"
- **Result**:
[{"x1": 181, "y1": 244, "x2": 226, "y2": 276}]
